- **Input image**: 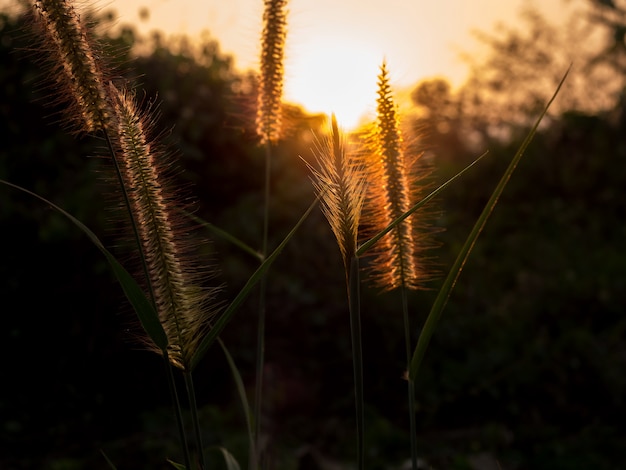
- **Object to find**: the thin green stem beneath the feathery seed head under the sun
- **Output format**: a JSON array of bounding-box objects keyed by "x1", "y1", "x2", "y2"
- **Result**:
[{"x1": 347, "y1": 256, "x2": 365, "y2": 470}]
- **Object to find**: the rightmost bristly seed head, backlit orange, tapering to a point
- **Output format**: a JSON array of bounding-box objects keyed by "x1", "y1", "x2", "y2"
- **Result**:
[{"x1": 365, "y1": 62, "x2": 429, "y2": 290}]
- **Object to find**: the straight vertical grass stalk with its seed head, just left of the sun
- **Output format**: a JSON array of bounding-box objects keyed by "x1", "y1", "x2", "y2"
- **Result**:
[{"x1": 250, "y1": 0, "x2": 287, "y2": 468}]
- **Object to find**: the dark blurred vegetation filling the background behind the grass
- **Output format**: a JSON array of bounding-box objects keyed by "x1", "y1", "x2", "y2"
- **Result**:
[{"x1": 0, "y1": 2, "x2": 626, "y2": 470}]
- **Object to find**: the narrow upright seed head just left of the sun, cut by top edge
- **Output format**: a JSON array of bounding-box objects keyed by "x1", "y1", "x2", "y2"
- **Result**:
[{"x1": 256, "y1": 0, "x2": 287, "y2": 143}]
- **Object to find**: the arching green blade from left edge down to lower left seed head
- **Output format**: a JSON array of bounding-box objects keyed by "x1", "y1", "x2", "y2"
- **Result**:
[{"x1": 0, "y1": 179, "x2": 167, "y2": 351}]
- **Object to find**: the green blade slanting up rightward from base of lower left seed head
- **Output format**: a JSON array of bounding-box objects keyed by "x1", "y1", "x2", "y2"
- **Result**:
[{"x1": 191, "y1": 198, "x2": 319, "y2": 370}]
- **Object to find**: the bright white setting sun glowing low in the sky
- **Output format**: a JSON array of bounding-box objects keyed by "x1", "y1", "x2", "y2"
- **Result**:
[{"x1": 285, "y1": 37, "x2": 383, "y2": 130}]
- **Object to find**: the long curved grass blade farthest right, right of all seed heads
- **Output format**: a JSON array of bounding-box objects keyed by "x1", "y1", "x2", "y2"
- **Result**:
[{"x1": 408, "y1": 65, "x2": 571, "y2": 380}]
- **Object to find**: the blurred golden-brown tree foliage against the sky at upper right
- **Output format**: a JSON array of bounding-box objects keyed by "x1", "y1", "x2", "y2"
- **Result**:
[{"x1": 413, "y1": 2, "x2": 626, "y2": 148}]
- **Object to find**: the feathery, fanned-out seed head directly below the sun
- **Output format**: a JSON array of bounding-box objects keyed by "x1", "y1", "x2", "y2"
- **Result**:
[{"x1": 310, "y1": 114, "x2": 365, "y2": 270}]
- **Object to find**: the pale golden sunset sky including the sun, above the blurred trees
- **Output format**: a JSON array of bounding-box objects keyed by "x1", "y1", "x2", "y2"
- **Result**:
[{"x1": 0, "y1": 0, "x2": 585, "y2": 127}]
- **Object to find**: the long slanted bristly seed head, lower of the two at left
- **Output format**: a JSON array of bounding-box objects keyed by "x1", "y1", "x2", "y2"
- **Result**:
[{"x1": 110, "y1": 85, "x2": 216, "y2": 370}]
